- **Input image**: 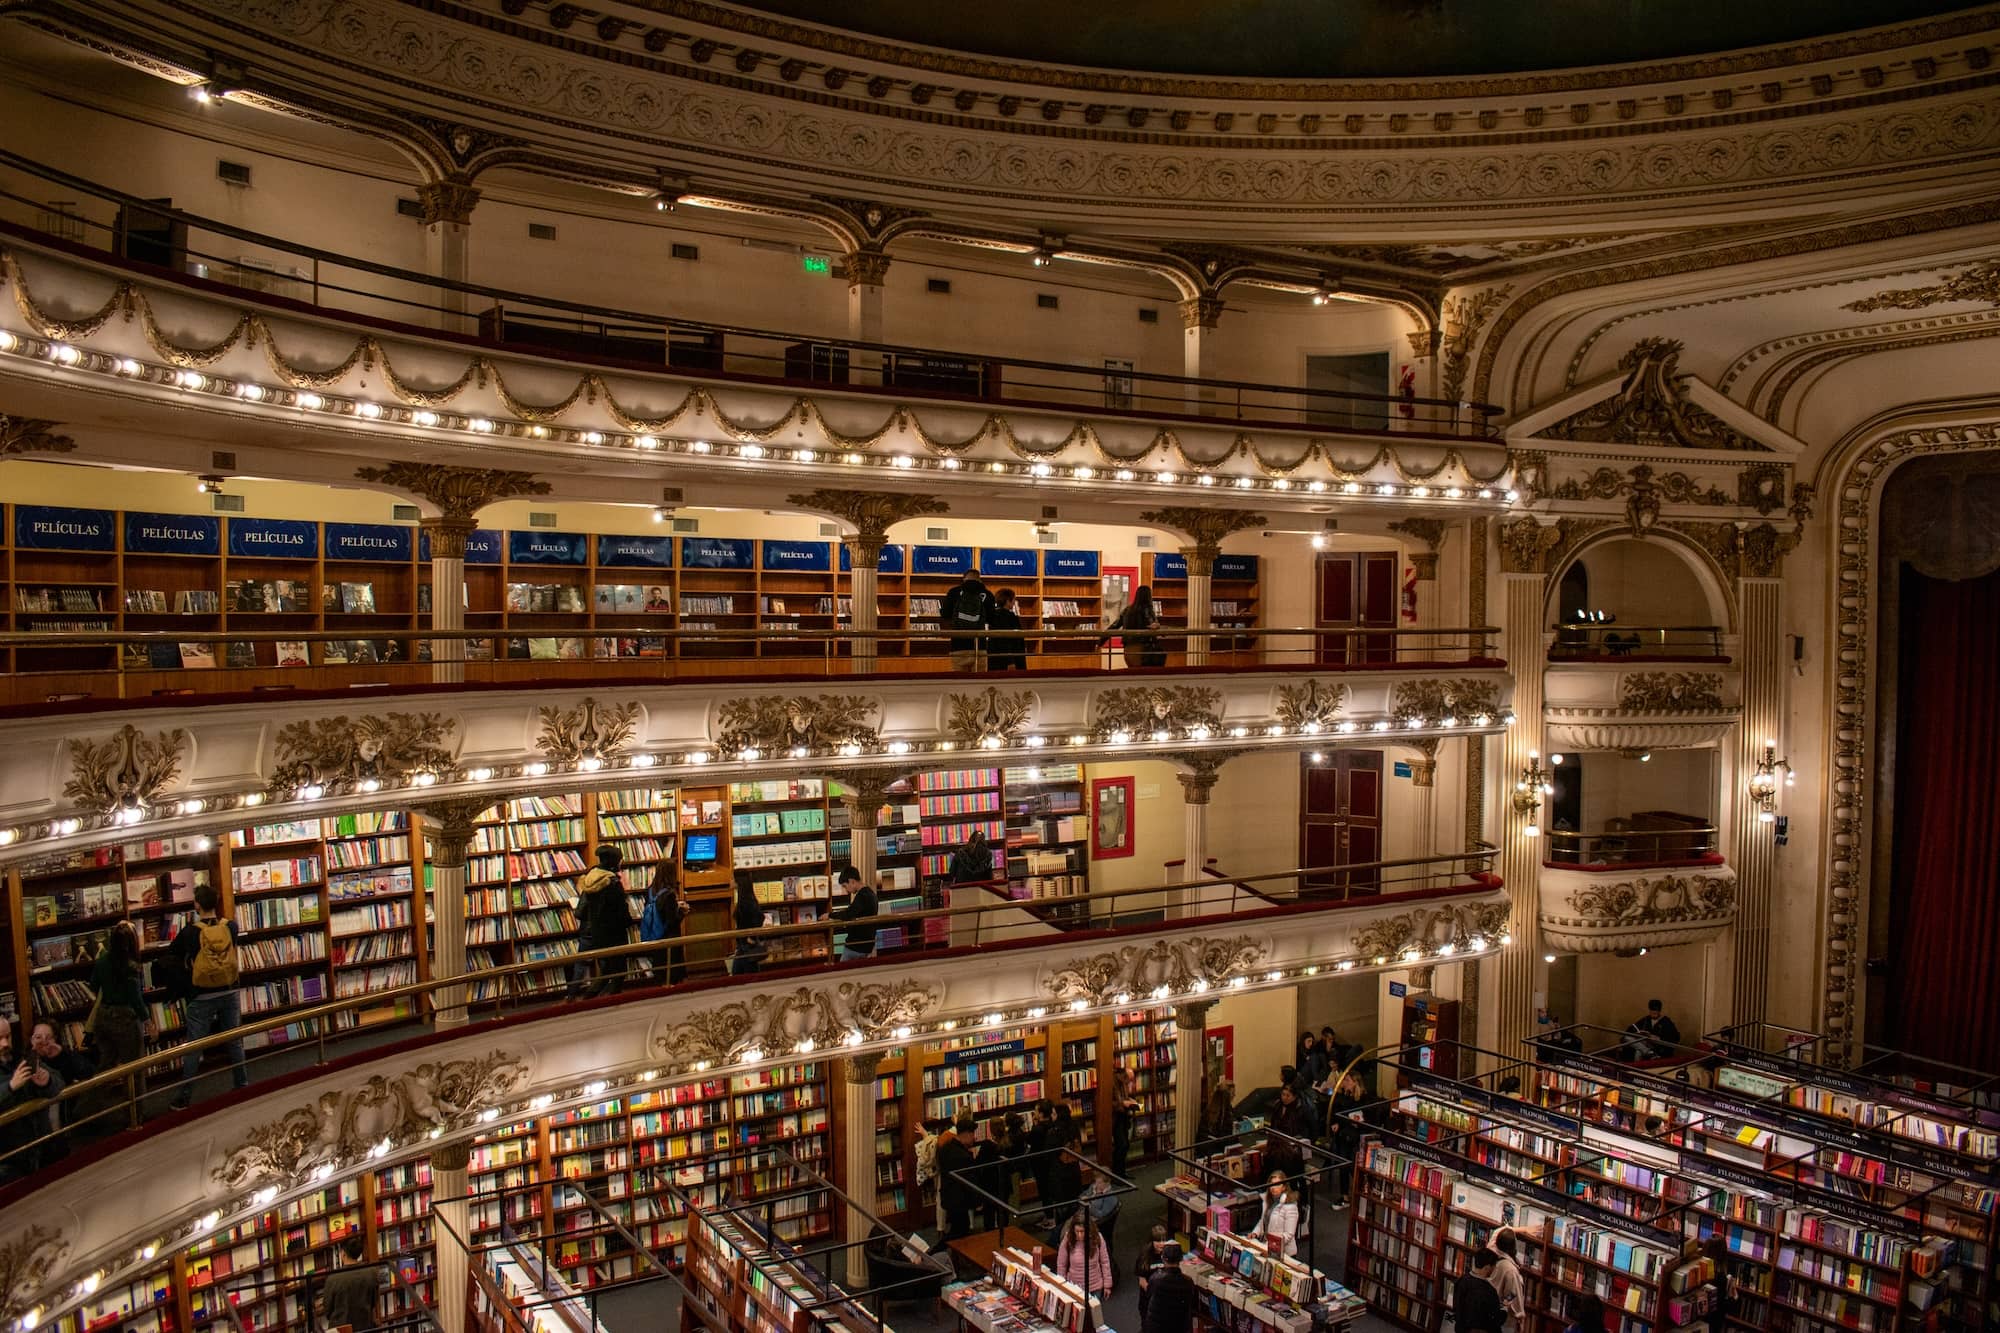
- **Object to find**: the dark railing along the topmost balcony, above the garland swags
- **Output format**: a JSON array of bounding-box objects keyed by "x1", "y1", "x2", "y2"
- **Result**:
[{"x1": 0, "y1": 152, "x2": 1500, "y2": 440}]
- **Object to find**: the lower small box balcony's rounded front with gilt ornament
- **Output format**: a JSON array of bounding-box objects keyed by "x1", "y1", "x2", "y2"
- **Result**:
[{"x1": 1538, "y1": 865, "x2": 1736, "y2": 953}]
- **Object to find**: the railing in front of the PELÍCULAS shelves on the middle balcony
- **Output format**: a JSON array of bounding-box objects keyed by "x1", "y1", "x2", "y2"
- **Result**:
[{"x1": 0, "y1": 614, "x2": 1500, "y2": 705}]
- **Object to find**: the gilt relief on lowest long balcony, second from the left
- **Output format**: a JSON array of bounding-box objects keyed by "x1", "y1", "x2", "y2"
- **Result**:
[{"x1": 210, "y1": 1051, "x2": 528, "y2": 1189}]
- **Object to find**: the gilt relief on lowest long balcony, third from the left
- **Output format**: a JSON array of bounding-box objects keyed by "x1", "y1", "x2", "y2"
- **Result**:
[{"x1": 654, "y1": 981, "x2": 944, "y2": 1069}]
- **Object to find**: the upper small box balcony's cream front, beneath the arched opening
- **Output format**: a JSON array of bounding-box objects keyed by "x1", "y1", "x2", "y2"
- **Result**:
[{"x1": 1542, "y1": 658, "x2": 1742, "y2": 751}]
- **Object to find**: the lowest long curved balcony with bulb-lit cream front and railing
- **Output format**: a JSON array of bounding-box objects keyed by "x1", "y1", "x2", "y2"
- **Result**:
[{"x1": 0, "y1": 849, "x2": 1510, "y2": 1319}]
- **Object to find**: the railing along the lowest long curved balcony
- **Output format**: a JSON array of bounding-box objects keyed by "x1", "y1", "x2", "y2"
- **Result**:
[{"x1": 0, "y1": 845, "x2": 1500, "y2": 1179}]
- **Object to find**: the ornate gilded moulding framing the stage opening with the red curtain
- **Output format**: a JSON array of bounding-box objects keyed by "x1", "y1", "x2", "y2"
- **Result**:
[{"x1": 1818, "y1": 420, "x2": 2000, "y2": 1053}]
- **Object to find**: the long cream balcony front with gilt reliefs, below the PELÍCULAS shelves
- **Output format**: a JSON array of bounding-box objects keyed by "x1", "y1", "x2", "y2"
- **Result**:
[{"x1": 0, "y1": 630, "x2": 1512, "y2": 863}]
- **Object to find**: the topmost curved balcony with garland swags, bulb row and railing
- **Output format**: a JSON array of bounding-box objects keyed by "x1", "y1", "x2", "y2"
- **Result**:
[{"x1": 0, "y1": 154, "x2": 1508, "y2": 516}]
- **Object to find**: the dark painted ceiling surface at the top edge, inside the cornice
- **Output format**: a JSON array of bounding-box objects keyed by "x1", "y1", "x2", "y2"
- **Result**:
[{"x1": 716, "y1": 0, "x2": 1966, "y2": 78}]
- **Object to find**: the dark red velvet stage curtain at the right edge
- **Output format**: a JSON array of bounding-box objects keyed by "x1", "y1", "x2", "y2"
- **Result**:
[{"x1": 1890, "y1": 568, "x2": 2000, "y2": 1071}]
